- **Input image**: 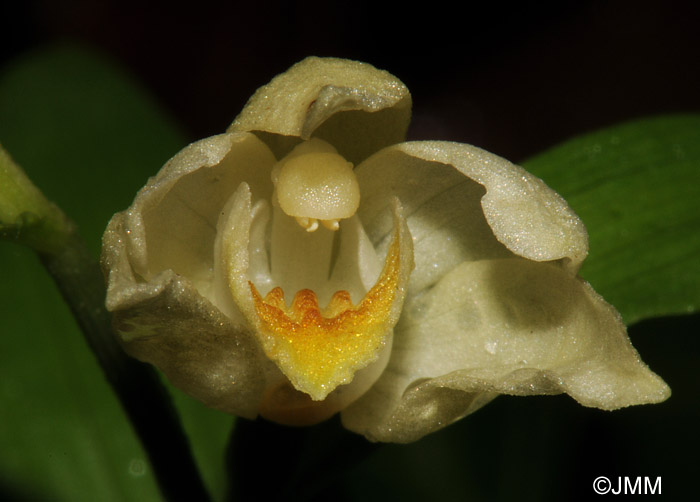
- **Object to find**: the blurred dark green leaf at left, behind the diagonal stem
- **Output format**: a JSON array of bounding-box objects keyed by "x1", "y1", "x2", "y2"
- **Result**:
[{"x1": 0, "y1": 46, "x2": 232, "y2": 501}]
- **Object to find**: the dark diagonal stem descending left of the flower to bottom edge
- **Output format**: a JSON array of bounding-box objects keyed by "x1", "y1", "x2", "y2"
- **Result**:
[{"x1": 39, "y1": 231, "x2": 210, "y2": 502}]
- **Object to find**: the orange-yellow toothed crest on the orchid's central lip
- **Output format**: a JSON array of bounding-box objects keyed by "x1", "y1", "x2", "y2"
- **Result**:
[{"x1": 248, "y1": 234, "x2": 400, "y2": 401}]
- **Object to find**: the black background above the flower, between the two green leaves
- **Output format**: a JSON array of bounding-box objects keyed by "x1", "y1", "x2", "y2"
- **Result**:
[{"x1": 2, "y1": 0, "x2": 700, "y2": 161}]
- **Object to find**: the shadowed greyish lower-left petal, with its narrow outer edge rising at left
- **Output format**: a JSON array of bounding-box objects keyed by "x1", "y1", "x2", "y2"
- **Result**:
[{"x1": 102, "y1": 213, "x2": 274, "y2": 418}]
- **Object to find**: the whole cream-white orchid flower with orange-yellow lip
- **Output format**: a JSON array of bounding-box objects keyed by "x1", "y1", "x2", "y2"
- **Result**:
[{"x1": 102, "y1": 58, "x2": 670, "y2": 442}]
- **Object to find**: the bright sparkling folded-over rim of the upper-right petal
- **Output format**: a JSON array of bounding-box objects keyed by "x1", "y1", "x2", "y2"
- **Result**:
[{"x1": 386, "y1": 141, "x2": 588, "y2": 271}]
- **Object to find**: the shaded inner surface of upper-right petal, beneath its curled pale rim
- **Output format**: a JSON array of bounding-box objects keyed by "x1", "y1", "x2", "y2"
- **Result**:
[{"x1": 355, "y1": 146, "x2": 513, "y2": 294}]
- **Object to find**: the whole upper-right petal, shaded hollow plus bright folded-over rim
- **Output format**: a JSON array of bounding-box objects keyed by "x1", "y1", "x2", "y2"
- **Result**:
[{"x1": 355, "y1": 141, "x2": 588, "y2": 292}]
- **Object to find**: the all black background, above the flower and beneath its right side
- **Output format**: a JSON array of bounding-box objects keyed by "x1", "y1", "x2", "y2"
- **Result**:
[{"x1": 0, "y1": 0, "x2": 700, "y2": 500}]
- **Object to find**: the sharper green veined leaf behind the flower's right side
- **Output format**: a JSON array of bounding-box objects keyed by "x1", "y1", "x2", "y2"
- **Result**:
[{"x1": 523, "y1": 115, "x2": 700, "y2": 323}]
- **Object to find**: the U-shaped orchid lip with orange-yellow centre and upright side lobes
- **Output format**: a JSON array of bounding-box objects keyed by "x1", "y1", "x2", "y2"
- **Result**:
[{"x1": 219, "y1": 167, "x2": 412, "y2": 401}]
